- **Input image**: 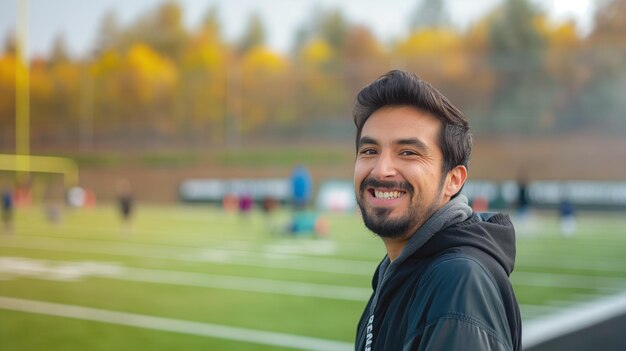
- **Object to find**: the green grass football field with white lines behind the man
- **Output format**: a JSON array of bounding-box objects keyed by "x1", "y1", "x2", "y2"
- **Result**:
[{"x1": 0, "y1": 204, "x2": 626, "y2": 351}]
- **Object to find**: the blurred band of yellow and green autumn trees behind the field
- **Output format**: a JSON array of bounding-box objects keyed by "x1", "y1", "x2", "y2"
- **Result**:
[{"x1": 0, "y1": 0, "x2": 626, "y2": 150}]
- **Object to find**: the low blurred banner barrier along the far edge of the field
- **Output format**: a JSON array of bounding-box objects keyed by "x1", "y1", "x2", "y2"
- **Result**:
[{"x1": 179, "y1": 178, "x2": 626, "y2": 210}]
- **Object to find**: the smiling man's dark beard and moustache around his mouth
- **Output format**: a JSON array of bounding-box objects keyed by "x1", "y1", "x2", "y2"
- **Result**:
[{"x1": 357, "y1": 178, "x2": 442, "y2": 239}]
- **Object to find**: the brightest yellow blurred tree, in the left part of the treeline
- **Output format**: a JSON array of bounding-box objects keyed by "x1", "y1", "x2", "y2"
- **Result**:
[{"x1": 91, "y1": 43, "x2": 178, "y2": 144}]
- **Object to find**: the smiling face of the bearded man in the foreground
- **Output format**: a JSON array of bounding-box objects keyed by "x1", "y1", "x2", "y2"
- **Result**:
[{"x1": 354, "y1": 106, "x2": 444, "y2": 238}]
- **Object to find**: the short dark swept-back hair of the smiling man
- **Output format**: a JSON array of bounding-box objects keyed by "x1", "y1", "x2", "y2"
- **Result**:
[{"x1": 352, "y1": 70, "x2": 472, "y2": 177}]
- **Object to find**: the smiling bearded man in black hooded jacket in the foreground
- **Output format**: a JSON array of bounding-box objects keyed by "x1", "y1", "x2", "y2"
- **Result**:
[{"x1": 353, "y1": 71, "x2": 521, "y2": 351}]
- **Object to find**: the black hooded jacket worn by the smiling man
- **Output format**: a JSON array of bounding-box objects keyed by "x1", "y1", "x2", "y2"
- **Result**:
[{"x1": 355, "y1": 214, "x2": 521, "y2": 351}]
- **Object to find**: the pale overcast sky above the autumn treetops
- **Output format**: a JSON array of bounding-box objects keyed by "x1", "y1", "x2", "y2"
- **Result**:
[{"x1": 0, "y1": 0, "x2": 593, "y2": 55}]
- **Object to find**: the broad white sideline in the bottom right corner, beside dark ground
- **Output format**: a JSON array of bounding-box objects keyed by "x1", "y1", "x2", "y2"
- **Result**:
[{"x1": 522, "y1": 293, "x2": 626, "y2": 348}]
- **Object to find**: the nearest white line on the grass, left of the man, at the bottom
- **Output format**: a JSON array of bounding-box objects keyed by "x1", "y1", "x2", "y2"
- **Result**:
[{"x1": 0, "y1": 296, "x2": 354, "y2": 351}]
